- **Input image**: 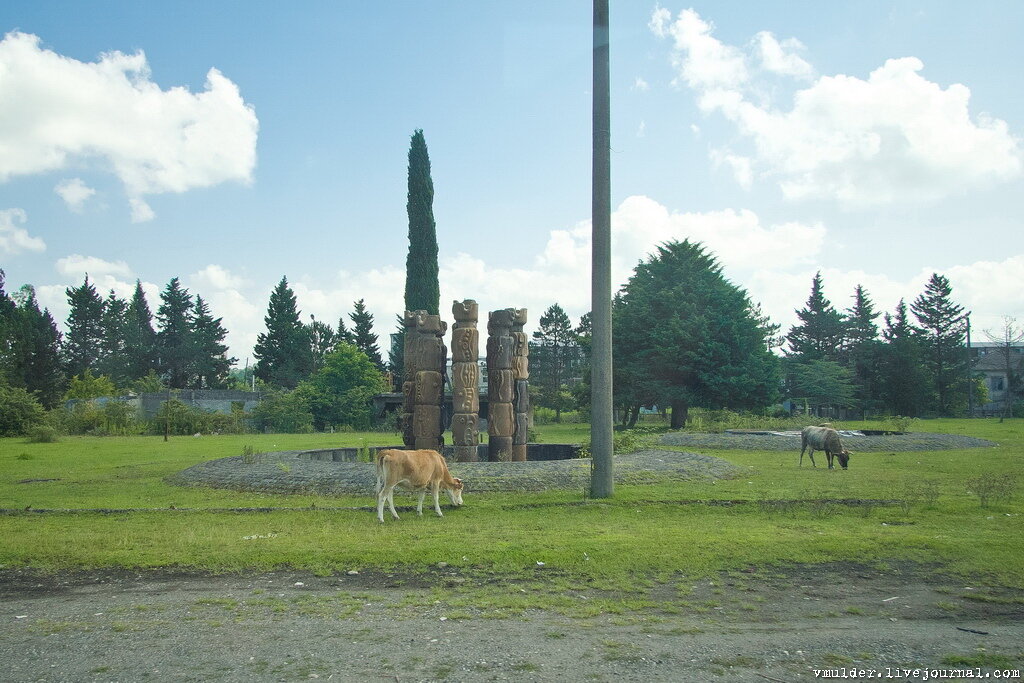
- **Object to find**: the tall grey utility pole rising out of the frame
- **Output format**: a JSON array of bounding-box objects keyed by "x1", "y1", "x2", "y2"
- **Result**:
[{"x1": 590, "y1": 0, "x2": 614, "y2": 498}]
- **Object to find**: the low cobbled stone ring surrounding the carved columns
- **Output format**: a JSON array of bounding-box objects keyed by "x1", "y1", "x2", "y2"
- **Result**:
[{"x1": 168, "y1": 449, "x2": 738, "y2": 496}]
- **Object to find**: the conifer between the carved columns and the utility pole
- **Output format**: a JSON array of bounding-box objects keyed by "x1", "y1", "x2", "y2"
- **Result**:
[{"x1": 530, "y1": 303, "x2": 581, "y2": 422}]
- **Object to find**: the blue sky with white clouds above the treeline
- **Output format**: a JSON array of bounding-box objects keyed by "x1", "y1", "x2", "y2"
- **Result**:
[{"x1": 0, "y1": 0, "x2": 1024, "y2": 362}]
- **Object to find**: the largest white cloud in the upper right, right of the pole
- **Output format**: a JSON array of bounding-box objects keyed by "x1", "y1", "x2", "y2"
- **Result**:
[{"x1": 650, "y1": 8, "x2": 1024, "y2": 206}]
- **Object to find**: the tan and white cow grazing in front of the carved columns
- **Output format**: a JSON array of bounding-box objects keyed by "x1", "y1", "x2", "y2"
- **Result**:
[{"x1": 374, "y1": 449, "x2": 462, "y2": 523}]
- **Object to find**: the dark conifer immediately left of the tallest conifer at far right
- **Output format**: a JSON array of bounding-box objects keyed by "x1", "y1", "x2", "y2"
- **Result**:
[{"x1": 879, "y1": 299, "x2": 924, "y2": 417}]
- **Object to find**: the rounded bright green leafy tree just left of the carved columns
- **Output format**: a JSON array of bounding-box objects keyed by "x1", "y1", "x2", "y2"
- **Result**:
[{"x1": 296, "y1": 342, "x2": 387, "y2": 430}]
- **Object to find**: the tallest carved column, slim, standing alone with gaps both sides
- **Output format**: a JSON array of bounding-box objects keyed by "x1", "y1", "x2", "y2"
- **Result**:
[{"x1": 452, "y1": 299, "x2": 480, "y2": 463}]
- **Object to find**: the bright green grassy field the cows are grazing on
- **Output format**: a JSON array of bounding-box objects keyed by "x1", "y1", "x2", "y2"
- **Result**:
[{"x1": 0, "y1": 420, "x2": 1024, "y2": 587}]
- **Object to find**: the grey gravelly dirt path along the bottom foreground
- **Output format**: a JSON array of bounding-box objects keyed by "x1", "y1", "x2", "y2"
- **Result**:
[{"x1": 0, "y1": 564, "x2": 1024, "y2": 683}]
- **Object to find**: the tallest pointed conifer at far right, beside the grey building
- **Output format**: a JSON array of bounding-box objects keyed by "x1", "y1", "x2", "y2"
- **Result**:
[{"x1": 910, "y1": 272, "x2": 967, "y2": 416}]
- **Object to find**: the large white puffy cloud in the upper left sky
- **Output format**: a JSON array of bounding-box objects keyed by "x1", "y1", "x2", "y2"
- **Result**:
[{"x1": 0, "y1": 32, "x2": 258, "y2": 221}]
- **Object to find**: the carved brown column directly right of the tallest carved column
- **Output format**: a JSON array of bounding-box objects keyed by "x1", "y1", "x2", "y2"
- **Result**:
[{"x1": 487, "y1": 308, "x2": 515, "y2": 462}]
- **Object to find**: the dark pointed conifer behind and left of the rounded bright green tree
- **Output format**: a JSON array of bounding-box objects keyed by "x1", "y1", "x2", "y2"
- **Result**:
[{"x1": 253, "y1": 278, "x2": 313, "y2": 389}]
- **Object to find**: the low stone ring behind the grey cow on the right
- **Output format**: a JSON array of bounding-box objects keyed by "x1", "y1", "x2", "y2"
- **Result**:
[{"x1": 660, "y1": 432, "x2": 998, "y2": 453}]
